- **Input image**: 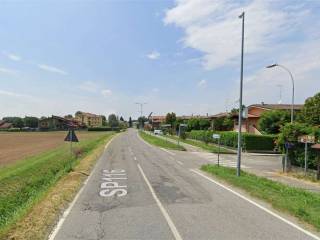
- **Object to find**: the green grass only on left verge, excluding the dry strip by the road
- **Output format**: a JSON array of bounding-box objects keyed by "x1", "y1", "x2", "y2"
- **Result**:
[{"x1": 0, "y1": 133, "x2": 114, "y2": 232}]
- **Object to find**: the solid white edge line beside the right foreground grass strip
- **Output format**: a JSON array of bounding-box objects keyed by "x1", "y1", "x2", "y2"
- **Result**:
[{"x1": 189, "y1": 169, "x2": 320, "y2": 240}]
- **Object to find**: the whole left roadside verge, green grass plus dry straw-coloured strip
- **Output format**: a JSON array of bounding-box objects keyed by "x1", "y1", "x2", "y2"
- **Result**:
[{"x1": 0, "y1": 134, "x2": 113, "y2": 239}]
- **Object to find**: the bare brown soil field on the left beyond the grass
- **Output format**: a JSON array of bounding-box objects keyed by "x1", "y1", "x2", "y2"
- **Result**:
[{"x1": 0, "y1": 131, "x2": 105, "y2": 167}]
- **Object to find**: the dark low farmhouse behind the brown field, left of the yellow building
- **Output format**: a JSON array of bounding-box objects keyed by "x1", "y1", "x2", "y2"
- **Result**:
[{"x1": 39, "y1": 116, "x2": 81, "y2": 130}]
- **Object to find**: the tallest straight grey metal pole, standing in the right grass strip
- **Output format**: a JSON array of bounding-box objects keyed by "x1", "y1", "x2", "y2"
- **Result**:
[{"x1": 237, "y1": 12, "x2": 245, "y2": 177}]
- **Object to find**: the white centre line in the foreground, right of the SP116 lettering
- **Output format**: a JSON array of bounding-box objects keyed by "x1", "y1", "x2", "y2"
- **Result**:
[{"x1": 137, "y1": 164, "x2": 182, "y2": 240}]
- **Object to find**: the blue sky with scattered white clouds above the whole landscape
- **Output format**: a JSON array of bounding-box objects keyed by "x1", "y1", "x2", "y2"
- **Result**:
[{"x1": 0, "y1": 0, "x2": 320, "y2": 119}]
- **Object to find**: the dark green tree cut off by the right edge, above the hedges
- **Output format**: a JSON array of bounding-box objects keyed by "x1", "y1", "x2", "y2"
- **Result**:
[{"x1": 301, "y1": 92, "x2": 320, "y2": 126}]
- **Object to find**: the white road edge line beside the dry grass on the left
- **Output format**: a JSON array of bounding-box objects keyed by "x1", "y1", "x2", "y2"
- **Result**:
[{"x1": 48, "y1": 135, "x2": 118, "y2": 240}]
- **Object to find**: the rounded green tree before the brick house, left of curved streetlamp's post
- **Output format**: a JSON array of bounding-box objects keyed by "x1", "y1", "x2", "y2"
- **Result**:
[{"x1": 258, "y1": 110, "x2": 290, "y2": 134}]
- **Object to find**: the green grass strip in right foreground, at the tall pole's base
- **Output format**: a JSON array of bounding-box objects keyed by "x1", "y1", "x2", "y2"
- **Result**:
[{"x1": 201, "y1": 165, "x2": 320, "y2": 230}]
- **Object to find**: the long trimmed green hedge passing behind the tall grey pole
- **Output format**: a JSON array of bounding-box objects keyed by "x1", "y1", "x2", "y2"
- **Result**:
[{"x1": 186, "y1": 130, "x2": 276, "y2": 151}]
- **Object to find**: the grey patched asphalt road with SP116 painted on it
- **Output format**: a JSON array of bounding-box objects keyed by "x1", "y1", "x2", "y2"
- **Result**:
[{"x1": 52, "y1": 130, "x2": 319, "y2": 240}]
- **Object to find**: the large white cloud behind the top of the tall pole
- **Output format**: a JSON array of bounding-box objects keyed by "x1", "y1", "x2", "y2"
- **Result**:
[{"x1": 164, "y1": 0, "x2": 305, "y2": 69}]
